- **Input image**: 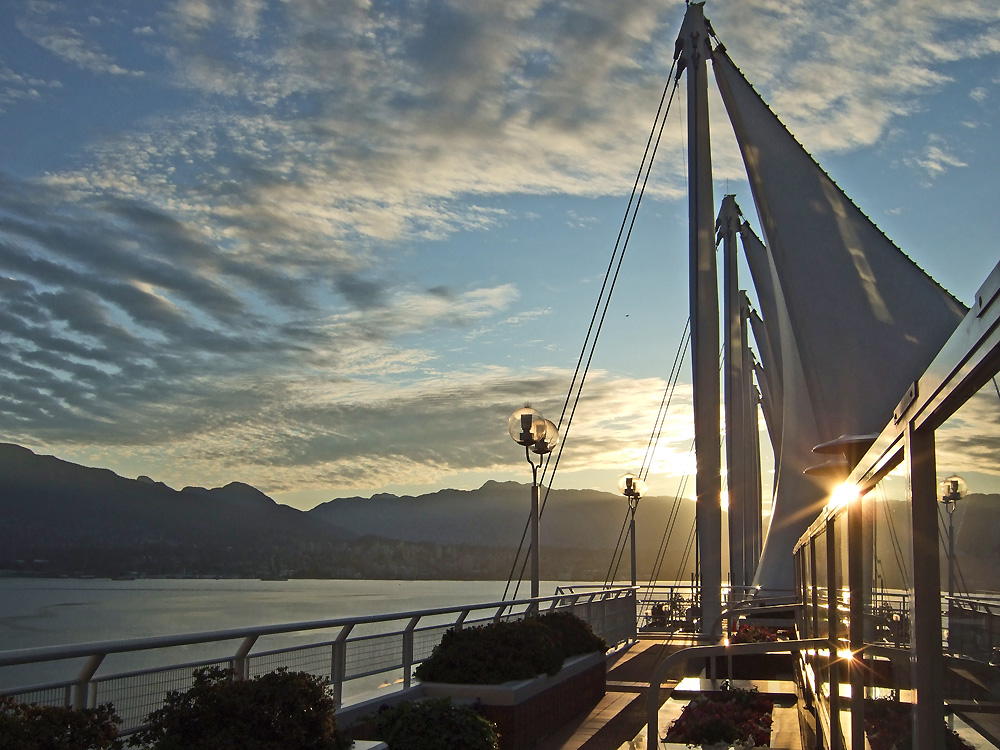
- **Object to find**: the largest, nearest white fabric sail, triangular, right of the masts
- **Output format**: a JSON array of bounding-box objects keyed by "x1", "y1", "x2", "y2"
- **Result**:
[{"x1": 713, "y1": 47, "x2": 966, "y2": 589}]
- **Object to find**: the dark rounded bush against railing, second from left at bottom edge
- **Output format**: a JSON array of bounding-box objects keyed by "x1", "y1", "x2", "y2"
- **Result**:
[{"x1": 129, "y1": 667, "x2": 351, "y2": 750}]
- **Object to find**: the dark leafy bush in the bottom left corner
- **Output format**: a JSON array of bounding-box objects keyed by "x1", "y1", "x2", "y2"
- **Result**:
[{"x1": 0, "y1": 695, "x2": 122, "y2": 750}]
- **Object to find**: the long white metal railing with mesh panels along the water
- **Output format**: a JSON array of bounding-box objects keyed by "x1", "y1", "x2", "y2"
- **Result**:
[{"x1": 0, "y1": 588, "x2": 636, "y2": 734}]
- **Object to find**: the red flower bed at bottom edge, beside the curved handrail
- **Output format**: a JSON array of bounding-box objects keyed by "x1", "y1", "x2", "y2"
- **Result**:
[{"x1": 663, "y1": 682, "x2": 774, "y2": 746}]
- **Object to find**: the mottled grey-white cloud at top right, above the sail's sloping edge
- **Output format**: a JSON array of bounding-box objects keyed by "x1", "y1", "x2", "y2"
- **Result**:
[{"x1": 712, "y1": 0, "x2": 1000, "y2": 152}]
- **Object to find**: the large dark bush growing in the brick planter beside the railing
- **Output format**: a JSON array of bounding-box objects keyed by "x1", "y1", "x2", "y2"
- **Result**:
[{"x1": 414, "y1": 612, "x2": 608, "y2": 685}]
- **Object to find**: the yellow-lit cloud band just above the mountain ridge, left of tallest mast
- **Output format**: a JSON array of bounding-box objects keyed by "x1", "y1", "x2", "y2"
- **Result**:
[{"x1": 47, "y1": 367, "x2": 691, "y2": 493}]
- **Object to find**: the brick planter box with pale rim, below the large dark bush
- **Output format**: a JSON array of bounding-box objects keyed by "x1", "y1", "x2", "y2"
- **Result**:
[{"x1": 420, "y1": 652, "x2": 607, "y2": 750}]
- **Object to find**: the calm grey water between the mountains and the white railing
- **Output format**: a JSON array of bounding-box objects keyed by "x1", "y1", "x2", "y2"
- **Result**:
[{"x1": 0, "y1": 578, "x2": 556, "y2": 688}]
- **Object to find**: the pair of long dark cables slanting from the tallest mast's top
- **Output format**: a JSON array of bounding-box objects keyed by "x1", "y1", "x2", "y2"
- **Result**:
[{"x1": 503, "y1": 58, "x2": 680, "y2": 599}]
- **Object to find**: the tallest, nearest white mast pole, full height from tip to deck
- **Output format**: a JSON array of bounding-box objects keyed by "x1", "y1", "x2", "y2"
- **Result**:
[{"x1": 677, "y1": 3, "x2": 722, "y2": 634}]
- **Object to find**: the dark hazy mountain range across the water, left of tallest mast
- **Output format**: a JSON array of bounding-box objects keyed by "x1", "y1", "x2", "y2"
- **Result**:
[{"x1": 0, "y1": 443, "x2": 694, "y2": 579}]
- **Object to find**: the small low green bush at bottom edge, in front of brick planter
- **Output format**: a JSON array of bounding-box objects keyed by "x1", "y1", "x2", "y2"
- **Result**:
[{"x1": 372, "y1": 698, "x2": 499, "y2": 750}]
